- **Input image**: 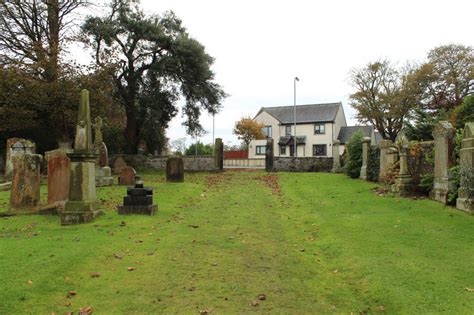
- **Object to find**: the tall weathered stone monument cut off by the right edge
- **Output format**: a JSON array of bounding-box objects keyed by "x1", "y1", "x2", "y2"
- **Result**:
[{"x1": 456, "y1": 122, "x2": 474, "y2": 214}]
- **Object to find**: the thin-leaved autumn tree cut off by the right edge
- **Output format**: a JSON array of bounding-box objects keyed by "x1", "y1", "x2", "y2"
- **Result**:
[{"x1": 410, "y1": 44, "x2": 474, "y2": 116}]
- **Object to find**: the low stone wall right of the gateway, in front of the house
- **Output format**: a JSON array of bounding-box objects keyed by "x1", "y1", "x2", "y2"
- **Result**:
[{"x1": 273, "y1": 157, "x2": 333, "y2": 172}]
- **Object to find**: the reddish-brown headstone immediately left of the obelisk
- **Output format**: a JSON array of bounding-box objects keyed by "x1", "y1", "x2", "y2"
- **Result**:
[{"x1": 45, "y1": 149, "x2": 71, "y2": 205}]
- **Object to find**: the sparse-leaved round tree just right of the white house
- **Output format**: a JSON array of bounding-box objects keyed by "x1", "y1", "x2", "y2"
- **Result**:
[{"x1": 350, "y1": 60, "x2": 415, "y2": 141}]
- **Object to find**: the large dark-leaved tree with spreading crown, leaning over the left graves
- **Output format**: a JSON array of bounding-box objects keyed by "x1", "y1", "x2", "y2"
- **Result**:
[{"x1": 82, "y1": 0, "x2": 226, "y2": 153}]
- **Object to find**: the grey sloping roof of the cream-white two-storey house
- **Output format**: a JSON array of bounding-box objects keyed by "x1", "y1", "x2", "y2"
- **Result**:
[{"x1": 257, "y1": 102, "x2": 342, "y2": 124}]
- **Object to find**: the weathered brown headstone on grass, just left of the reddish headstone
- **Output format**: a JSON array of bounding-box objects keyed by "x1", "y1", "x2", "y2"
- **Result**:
[{"x1": 10, "y1": 154, "x2": 42, "y2": 210}]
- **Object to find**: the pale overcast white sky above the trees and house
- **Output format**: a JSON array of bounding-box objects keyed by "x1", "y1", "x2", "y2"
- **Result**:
[{"x1": 95, "y1": 0, "x2": 474, "y2": 145}]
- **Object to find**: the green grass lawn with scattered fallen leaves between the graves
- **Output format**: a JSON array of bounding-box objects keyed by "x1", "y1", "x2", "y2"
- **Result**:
[{"x1": 0, "y1": 172, "x2": 474, "y2": 314}]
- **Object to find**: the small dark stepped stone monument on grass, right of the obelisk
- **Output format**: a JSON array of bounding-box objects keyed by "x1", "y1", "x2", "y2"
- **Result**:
[{"x1": 117, "y1": 181, "x2": 158, "y2": 215}]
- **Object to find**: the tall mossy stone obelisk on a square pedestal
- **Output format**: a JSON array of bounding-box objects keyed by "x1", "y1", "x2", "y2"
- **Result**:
[{"x1": 61, "y1": 90, "x2": 98, "y2": 225}]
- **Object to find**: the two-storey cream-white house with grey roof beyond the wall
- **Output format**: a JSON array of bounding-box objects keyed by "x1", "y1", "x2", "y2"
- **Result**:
[{"x1": 249, "y1": 102, "x2": 347, "y2": 159}]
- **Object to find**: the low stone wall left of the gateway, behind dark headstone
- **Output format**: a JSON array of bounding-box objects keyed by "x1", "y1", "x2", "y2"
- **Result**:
[{"x1": 109, "y1": 154, "x2": 218, "y2": 172}]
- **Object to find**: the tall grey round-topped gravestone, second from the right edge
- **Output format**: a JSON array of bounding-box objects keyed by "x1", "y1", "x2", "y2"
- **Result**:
[{"x1": 430, "y1": 121, "x2": 456, "y2": 204}]
